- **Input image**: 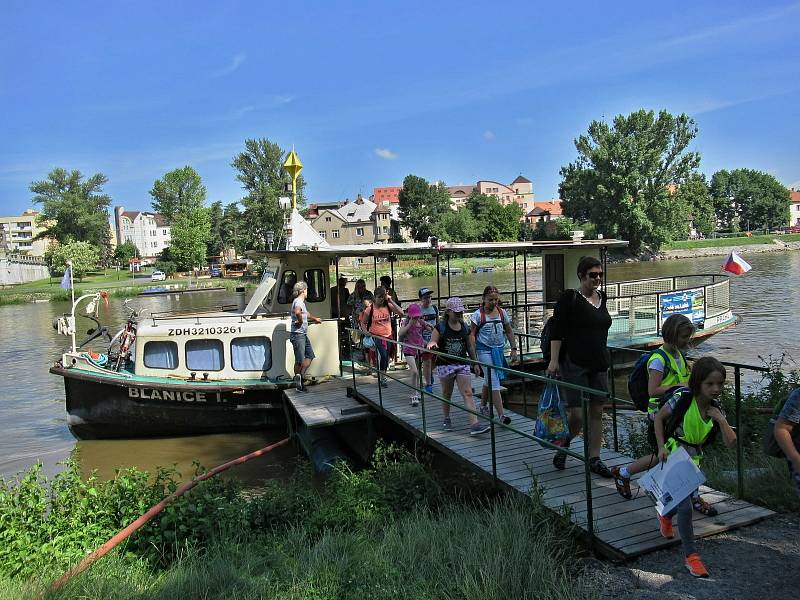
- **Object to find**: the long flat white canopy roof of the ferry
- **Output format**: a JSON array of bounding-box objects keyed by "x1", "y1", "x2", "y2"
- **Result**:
[{"x1": 257, "y1": 239, "x2": 628, "y2": 258}]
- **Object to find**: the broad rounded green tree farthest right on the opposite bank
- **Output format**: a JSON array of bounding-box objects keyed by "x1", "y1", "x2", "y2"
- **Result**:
[{"x1": 711, "y1": 169, "x2": 791, "y2": 231}]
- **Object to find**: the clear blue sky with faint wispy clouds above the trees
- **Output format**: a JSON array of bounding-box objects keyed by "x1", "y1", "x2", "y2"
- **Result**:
[{"x1": 0, "y1": 0, "x2": 800, "y2": 214}]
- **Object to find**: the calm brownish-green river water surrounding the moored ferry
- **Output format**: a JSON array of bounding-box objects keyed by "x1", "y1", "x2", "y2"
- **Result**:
[{"x1": 0, "y1": 252, "x2": 800, "y2": 481}]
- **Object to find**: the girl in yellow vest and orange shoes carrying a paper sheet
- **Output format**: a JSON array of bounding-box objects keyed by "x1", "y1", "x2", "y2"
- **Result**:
[{"x1": 654, "y1": 356, "x2": 736, "y2": 577}]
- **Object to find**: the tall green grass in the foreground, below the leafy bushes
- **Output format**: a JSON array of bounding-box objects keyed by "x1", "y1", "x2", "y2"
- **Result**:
[{"x1": 0, "y1": 498, "x2": 599, "y2": 600}]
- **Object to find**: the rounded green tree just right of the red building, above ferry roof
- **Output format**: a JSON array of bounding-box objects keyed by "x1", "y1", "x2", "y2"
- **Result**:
[{"x1": 399, "y1": 175, "x2": 450, "y2": 242}]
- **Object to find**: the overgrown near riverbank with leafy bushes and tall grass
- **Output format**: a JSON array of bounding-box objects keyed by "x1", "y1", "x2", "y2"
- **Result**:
[{"x1": 0, "y1": 445, "x2": 598, "y2": 600}]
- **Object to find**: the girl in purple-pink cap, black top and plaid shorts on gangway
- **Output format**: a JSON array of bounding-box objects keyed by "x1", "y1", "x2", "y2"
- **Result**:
[{"x1": 428, "y1": 296, "x2": 490, "y2": 435}]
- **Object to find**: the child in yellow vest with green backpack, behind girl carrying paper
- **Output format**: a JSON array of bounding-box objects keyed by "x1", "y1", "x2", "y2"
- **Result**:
[{"x1": 611, "y1": 314, "x2": 694, "y2": 500}]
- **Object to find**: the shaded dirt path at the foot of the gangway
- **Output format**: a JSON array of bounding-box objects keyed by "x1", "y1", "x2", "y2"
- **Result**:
[{"x1": 592, "y1": 514, "x2": 800, "y2": 600}]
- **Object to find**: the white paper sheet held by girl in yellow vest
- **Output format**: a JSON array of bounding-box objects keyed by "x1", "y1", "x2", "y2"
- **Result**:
[{"x1": 639, "y1": 448, "x2": 706, "y2": 516}]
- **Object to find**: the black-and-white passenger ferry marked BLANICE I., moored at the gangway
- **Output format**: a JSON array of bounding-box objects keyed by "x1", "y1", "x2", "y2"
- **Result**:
[{"x1": 50, "y1": 210, "x2": 735, "y2": 438}]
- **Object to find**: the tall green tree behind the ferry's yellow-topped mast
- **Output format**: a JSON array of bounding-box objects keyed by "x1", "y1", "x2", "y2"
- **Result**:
[{"x1": 231, "y1": 138, "x2": 305, "y2": 250}]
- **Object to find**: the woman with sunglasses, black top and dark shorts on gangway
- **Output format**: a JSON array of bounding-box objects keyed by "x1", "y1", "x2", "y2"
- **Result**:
[{"x1": 547, "y1": 256, "x2": 611, "y2": 477}]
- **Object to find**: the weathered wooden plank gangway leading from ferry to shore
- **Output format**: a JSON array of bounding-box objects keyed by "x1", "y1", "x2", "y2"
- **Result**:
[{"x1": 340, "y1": 373, "x2": 774, "y2": 560}]
